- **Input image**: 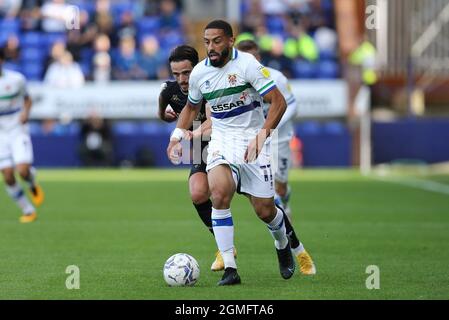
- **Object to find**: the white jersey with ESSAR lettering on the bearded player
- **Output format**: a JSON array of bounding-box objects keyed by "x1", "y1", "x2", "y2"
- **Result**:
[{"x1": 189, "y1": 48, "x2": 276, "y2": 163}]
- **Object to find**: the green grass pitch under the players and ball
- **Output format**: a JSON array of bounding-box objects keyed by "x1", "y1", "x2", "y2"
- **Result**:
[{"x1": 0, "y1": 170, "x2": 449, "y2": 300}]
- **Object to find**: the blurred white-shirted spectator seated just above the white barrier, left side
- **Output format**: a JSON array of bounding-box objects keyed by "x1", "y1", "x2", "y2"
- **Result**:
[{"x1": 44, "y1": 51, "x2": 84, "y2": 88}]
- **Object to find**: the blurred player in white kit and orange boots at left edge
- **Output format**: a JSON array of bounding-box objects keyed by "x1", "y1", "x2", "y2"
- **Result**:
[{"x1": 0, "y1": 50, "x2": 44, "y2": 223}]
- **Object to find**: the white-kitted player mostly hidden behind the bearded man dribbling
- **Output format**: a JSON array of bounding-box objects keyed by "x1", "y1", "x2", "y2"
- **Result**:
[{"x1": 237, "y1": 40, "x2": 297, "y2": 221}]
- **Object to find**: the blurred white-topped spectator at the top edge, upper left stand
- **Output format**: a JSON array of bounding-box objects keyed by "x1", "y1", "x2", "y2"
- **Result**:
[{"x1": 41, "y1": 0, "x2": 71, "y2": 32}]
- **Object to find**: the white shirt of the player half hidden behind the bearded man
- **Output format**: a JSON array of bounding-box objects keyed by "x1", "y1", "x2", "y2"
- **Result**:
[{"x1": 264, "y1": 67, "x2": 297, "y2": 143}]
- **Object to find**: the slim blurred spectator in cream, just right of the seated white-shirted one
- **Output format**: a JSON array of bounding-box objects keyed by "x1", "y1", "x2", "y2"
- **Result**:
[{"x1": 93, "y1": 34, "x2": 111, "y2": 83}]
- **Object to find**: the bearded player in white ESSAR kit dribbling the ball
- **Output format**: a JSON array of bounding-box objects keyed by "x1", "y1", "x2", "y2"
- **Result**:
[{"x1": 167, "y1": 20, "x2": 314, "y2": 286}]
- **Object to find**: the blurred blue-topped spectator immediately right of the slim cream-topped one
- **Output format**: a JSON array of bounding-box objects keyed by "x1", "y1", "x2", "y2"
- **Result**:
[{"x1": 112, "y1": 36, "x2": 146, "y2": 80}]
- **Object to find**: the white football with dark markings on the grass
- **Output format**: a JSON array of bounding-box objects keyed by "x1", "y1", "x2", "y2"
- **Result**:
[{"x1": 164, "y1": 253, "x2": 200, "y2": 287}]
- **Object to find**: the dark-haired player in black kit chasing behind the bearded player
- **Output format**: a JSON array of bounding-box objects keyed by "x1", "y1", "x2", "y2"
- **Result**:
[{"x1": 158, "y1": 45, "x2": 236, "y2": 271}]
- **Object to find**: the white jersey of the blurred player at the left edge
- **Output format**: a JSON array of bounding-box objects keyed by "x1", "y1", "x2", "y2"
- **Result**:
[{"x1": 0, "y1": 70, "x2": 27, "y2": 135}]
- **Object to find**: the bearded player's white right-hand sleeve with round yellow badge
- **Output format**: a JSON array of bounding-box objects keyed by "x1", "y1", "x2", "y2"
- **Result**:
[{"x1": 245, "y1": 56, "x2": 276, "y2": 97}]
